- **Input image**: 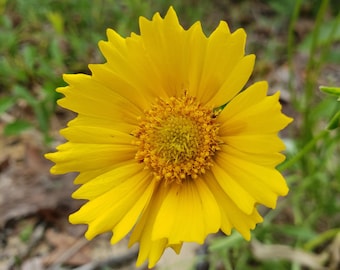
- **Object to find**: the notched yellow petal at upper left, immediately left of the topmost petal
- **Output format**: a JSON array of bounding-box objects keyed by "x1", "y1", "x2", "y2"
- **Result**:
[{"x1": 98, "y1": 31, "x2": 167, "y2": 104}]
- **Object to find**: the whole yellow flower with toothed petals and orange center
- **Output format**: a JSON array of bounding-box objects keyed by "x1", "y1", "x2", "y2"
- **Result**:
[{"x1": 46, "y1": 8, "x2": 291, "y2": 267}]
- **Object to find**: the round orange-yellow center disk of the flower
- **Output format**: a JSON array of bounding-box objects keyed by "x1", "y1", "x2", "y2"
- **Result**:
[{"x1": 133, "y1": 94, "x2": 220, "y2": 183}]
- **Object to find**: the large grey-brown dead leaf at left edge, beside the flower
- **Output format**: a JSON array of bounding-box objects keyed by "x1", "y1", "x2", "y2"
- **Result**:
[{"x1": 0, "y1": 166, "x2": 79, "y2": 227}]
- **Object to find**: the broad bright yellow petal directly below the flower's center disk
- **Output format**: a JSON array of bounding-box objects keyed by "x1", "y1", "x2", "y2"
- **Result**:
[{"x1": 152, "y1": 179, "x2": 221, "y2": 244}]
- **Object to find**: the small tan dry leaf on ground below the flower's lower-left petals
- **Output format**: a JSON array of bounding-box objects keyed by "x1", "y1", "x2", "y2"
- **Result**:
[{"x1": 43, "y1": 229, "x2": 91, "y2": 266}]
